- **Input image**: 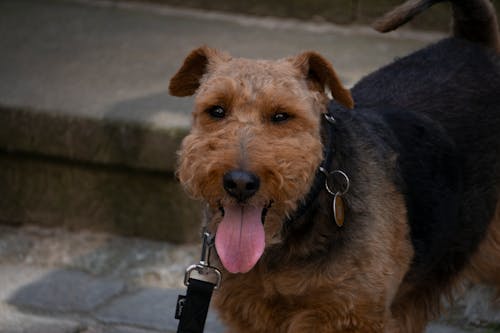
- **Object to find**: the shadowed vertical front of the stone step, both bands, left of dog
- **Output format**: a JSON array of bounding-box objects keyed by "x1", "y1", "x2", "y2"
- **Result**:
[{"x1": 0, "y1": 108, "x2": 200, "y2": 242}]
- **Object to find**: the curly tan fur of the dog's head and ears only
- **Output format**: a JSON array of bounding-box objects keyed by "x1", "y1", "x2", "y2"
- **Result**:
[{"x1": 174, "y1": 47, "x2": 353, "y2": 236}]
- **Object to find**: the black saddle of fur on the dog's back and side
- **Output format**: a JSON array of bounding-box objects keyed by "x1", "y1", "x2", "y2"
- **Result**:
[{"x1": 330, "y1": 38, "x2": 500, "y2": 288}]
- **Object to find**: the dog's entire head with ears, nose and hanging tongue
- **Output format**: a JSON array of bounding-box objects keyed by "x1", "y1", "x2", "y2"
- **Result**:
[{"x1": 169, "y1": 47, "x2": 353, "y2": 273}]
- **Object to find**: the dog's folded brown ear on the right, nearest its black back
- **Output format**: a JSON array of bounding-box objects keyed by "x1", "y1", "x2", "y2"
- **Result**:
[{"x1": 293, "y1": 52, "x2": 354, "y2": 109}]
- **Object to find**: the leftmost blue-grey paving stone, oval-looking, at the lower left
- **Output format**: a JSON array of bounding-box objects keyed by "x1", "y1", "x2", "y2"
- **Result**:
[{"x1": 9, "y1": 270, "x2": 125, "y2": 312}]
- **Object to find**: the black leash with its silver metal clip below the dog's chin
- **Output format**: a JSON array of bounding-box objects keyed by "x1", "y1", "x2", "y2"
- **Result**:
[{"x1": 175, "y1": 232, "x2": 222, "y2": 333}]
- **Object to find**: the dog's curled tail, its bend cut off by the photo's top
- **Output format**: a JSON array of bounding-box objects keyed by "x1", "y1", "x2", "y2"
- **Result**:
[{"x1": 373, "y1": 0, "x2": 500, "y2": 53}]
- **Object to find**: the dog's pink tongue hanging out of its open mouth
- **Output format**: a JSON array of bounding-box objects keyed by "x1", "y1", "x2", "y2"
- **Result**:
[{"x1": 215, "y1": 205, "x2": 265, "y2": 273}]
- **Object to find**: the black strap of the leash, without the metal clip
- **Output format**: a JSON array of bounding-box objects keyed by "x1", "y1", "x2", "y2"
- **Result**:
[{"x1": 175, "y1": 278, "x2": 215, "y2": 333}]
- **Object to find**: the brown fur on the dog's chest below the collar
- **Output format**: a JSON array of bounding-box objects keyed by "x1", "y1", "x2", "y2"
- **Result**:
[{"x1": 215, "y1": 175, "x2": 412, "y2": 333}]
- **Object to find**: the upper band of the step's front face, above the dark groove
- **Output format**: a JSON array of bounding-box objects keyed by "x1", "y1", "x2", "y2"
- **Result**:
[{"x1": 0, "y1": 104, "x2": 188, "y2": 174}]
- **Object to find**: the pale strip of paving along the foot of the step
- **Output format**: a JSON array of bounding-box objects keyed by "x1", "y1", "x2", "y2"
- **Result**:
[{"x1": 0, "y1": 225, "x2": 201, "y2": 290}]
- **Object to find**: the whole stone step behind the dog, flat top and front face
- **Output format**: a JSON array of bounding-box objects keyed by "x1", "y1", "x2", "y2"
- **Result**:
[{"x1": 0, "y1": 0, "x2": 442, "y2": 242}]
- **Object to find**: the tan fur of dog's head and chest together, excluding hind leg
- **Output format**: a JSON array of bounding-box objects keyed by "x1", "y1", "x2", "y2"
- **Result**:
[{"x1": 170, "y1": 47, "x2": 412, "y2": 332}]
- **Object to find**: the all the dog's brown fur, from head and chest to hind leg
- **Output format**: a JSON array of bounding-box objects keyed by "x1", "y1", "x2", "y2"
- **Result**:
[{"x1": 169, "y1": 0, "x2": 500, "y2": 333}]
